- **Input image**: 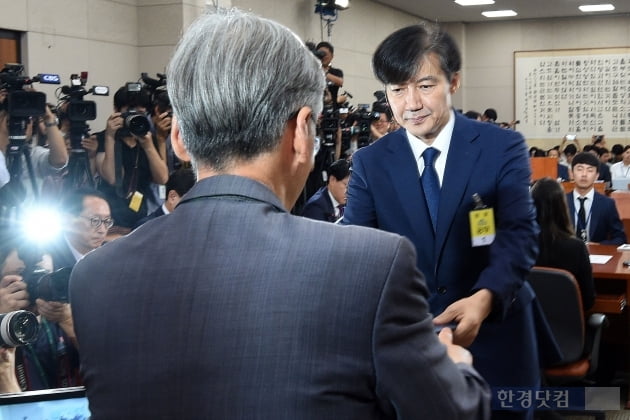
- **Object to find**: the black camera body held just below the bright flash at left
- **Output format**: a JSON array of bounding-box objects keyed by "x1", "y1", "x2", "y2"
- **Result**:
[{"x1": 22, "y1": 267, "x2": 72, "y2": 303}]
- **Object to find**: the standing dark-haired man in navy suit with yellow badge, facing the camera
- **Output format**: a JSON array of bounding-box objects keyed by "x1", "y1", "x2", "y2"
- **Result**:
[{"x1": 344, "y1": 25, "x2": 539, "y2": 418}]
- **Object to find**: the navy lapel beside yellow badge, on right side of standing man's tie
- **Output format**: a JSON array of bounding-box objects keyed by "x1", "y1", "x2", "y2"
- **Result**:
[{"x1": 436, "y1": 113, "x2": 480, "y2": 261}]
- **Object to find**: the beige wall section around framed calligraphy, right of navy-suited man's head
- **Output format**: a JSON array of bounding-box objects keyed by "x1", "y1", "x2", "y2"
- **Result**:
[{"x1": 454, "y1": 15, "x2": 630, "y2": 149}]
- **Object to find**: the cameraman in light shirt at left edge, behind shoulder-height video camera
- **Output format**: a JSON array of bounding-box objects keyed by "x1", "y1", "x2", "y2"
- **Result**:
[{"x1": 0, "y1": 64, "x2": 68, "y2": 218}]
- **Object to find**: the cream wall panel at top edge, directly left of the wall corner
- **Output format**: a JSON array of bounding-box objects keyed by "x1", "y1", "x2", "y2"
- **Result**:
[{"x1": 87, "y1": 0, "x2": 138, "y2": 46}]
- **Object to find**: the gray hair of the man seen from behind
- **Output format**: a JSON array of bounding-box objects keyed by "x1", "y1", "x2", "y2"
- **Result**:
[{"x1": 167, "y1": 10, "x2": 325, "y2": 172}]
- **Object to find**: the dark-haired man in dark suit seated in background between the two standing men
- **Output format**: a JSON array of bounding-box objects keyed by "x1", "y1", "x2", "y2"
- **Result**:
[{"x1": 302, "y1": 159, "x2": 350, "y2": 222}]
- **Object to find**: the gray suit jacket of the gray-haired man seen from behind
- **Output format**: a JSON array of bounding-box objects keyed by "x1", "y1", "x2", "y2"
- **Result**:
[{"x1": 70, "y1": 175, "x2": 489, "y2": 420}]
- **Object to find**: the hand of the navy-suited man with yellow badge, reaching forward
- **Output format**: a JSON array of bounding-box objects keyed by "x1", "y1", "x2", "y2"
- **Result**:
[{"x1": 433, "y1": 289, "x2": 492, "y2": 347}]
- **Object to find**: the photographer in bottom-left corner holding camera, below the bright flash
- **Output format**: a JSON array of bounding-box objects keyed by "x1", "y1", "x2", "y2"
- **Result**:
[{"x1": 0, "y1": 226, "x2": 81, "y2": 391}]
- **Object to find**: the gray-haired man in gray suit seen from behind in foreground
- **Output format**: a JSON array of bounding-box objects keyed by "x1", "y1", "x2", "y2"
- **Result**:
[{"x1": 70, "y1": 10, "x2": 489, "y2": 420}]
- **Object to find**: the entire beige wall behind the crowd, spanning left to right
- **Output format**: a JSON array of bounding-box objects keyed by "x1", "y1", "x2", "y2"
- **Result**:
[{"x1": 0, "y1": 0, "x2": 630, "y2": 146}]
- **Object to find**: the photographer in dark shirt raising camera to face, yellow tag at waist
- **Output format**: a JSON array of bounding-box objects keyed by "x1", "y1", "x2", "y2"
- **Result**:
[{"x1": 98, "y1": 83, "x2": 168, "y2": 233}]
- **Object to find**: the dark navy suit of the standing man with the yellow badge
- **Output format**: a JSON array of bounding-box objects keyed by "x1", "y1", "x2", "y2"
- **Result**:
[{"x1": 343, "y1": 113, "x2": 549, "y2": 386}]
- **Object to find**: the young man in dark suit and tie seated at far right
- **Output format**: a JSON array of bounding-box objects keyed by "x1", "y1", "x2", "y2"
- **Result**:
[{"x1": 567, "y1": 152, "x2": 626, "y2": 245}]
